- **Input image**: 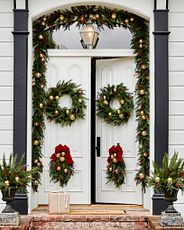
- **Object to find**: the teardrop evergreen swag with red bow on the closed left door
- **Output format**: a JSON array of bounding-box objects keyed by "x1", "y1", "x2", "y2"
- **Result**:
[{"x1": 49, "y1": 144, "x2": 74, "y2": 187}]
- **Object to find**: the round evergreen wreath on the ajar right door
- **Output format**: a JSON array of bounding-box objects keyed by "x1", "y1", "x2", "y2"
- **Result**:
[{"x1": 96, "y1": 83, "x2": 134, "y2": 126}]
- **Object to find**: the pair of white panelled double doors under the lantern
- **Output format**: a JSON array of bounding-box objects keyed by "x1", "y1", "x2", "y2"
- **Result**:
[{"x1": 38, "y1": 51, "x2": 142, "y2": 204}]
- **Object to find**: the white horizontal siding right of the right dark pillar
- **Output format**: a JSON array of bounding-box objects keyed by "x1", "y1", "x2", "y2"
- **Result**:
[{"x1": 169, "y1": 0, "x2": 184, "y2": 216}]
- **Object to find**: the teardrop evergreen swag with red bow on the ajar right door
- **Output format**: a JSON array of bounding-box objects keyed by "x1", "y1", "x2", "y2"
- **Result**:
[{"x1": 106, "y1": 143, "x2": 126, "y2": 188}]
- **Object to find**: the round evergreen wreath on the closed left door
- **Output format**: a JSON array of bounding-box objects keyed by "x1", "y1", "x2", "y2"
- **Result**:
[{"x1": 45, "y1": 80, "x2": 86, "y2": 126}]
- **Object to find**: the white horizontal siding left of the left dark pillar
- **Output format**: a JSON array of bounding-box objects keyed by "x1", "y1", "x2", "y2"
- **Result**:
[{"x1": 0, "y1": 0, "x2": 13, "y2": 211}]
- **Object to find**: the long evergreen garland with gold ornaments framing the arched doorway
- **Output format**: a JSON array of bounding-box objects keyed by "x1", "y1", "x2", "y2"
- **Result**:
[{"x1": 32, "y1": 5, "x2": 149, "y2": 191}]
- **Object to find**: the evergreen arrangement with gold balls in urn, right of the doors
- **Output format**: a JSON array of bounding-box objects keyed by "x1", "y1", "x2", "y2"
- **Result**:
[{"x1": 147, "y1": 152, "x2": 184, "y2": 213}]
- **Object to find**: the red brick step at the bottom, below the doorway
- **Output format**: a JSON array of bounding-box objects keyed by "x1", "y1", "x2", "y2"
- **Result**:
[{"x1": 32, "y1": 215, "x2": 148, "y2": 230}]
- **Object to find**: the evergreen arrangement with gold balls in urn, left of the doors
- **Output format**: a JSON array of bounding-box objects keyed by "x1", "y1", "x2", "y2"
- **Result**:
[{"x1": 0, "y1": 154, "x2": 37, "y2": 213}]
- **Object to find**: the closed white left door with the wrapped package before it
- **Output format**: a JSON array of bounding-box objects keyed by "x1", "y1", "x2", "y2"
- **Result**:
[{"x1": 38, "y1": 56, "x2": 91, "y2": 204}]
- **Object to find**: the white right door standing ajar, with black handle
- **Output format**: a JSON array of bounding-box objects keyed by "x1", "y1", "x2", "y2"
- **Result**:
[{"x1": 96, "y1": 58, "x2": 142, "y2": 204}]
